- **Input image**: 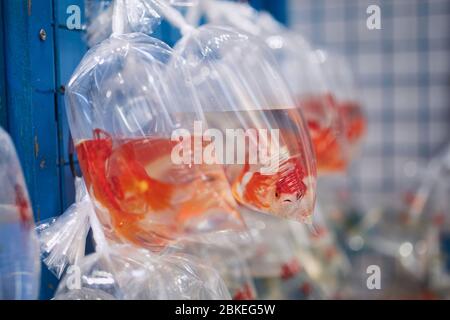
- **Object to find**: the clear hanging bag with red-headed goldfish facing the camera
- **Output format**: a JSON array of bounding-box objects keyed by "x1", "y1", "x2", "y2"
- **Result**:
[{"x1": 85, "y1": 1, "x2": 315, "y2": 220}]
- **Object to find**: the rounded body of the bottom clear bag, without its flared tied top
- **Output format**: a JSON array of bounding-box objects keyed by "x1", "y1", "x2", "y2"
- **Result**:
[{"x1": 55, "y1": 245, "x2": 230, "y2": 300}]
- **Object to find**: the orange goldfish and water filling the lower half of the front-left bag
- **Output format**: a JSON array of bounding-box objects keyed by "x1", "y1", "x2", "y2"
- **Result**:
[{"x1": 76, "y1": 130, "x2": 241, "y2": 247}]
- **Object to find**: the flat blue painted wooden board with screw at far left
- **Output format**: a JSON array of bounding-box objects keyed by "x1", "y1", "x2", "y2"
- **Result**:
[{"x1": 3, "y1": 0, "x2": 61, "y2": 296}]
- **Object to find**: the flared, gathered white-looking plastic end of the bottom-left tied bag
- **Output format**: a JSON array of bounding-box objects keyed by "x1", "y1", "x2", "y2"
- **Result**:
[{"x1": 36, "y1": 178, "x2": 92, "y2": 279}]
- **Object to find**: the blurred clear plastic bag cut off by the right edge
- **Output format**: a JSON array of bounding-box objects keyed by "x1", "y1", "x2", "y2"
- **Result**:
[{"x1": 366, "y1": 145, "x2": 450, "y2": 293}]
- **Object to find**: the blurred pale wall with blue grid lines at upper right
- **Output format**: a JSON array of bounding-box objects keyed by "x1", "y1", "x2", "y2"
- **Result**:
[{"x1": 289, "y1": 0, "x2": 450, "y2": 209}]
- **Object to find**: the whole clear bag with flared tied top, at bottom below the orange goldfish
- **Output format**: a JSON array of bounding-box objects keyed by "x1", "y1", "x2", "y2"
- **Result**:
[{"x1": 36, "y1": 175, "x2": 229, "y2": 300}]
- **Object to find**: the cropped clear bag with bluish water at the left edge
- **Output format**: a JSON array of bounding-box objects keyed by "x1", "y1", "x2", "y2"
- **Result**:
[{"x1": 0, "y1": 127, "x2": 41, "y2": 300}]
